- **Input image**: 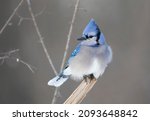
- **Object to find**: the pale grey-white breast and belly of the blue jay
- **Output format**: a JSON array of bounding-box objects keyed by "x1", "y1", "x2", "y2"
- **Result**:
[{"x1": 69, "y1": 46, "x2": 112, "y2": 80}]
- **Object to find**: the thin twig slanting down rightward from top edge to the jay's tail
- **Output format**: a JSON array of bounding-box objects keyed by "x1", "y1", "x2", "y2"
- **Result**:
[{"x1": 26, "y1": 0, "x2": 57, "y2": 75}]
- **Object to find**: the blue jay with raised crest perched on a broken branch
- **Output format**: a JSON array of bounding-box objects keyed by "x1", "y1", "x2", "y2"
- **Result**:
[{"x1": 48, "y1": 19, "x2": 112, "y2": 87}]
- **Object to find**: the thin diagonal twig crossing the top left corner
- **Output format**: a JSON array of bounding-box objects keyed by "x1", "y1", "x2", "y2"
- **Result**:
[{"x1": 0, "y1": 0, "x2": 24, "y2": 34}]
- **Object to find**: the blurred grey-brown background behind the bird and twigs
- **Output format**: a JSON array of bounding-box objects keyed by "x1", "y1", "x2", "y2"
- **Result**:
[{"x1": 0, "y1": 0, "x2": 150, "y2": 104}]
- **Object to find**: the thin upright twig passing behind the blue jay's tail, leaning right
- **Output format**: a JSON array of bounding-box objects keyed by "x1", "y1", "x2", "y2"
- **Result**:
[{"x1": 52, "y1": 0, "x2": 80, "y2": 104}]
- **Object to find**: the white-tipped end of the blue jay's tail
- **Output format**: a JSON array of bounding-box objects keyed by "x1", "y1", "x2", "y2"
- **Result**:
[{"x1": 48, "y1": 76, "x2": 68, "y2": 87}]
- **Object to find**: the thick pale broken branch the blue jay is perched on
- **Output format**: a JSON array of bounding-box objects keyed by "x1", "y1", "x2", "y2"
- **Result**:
[{"x1": 64, "y1": 79, "x2": 96, "y2": 104}]
